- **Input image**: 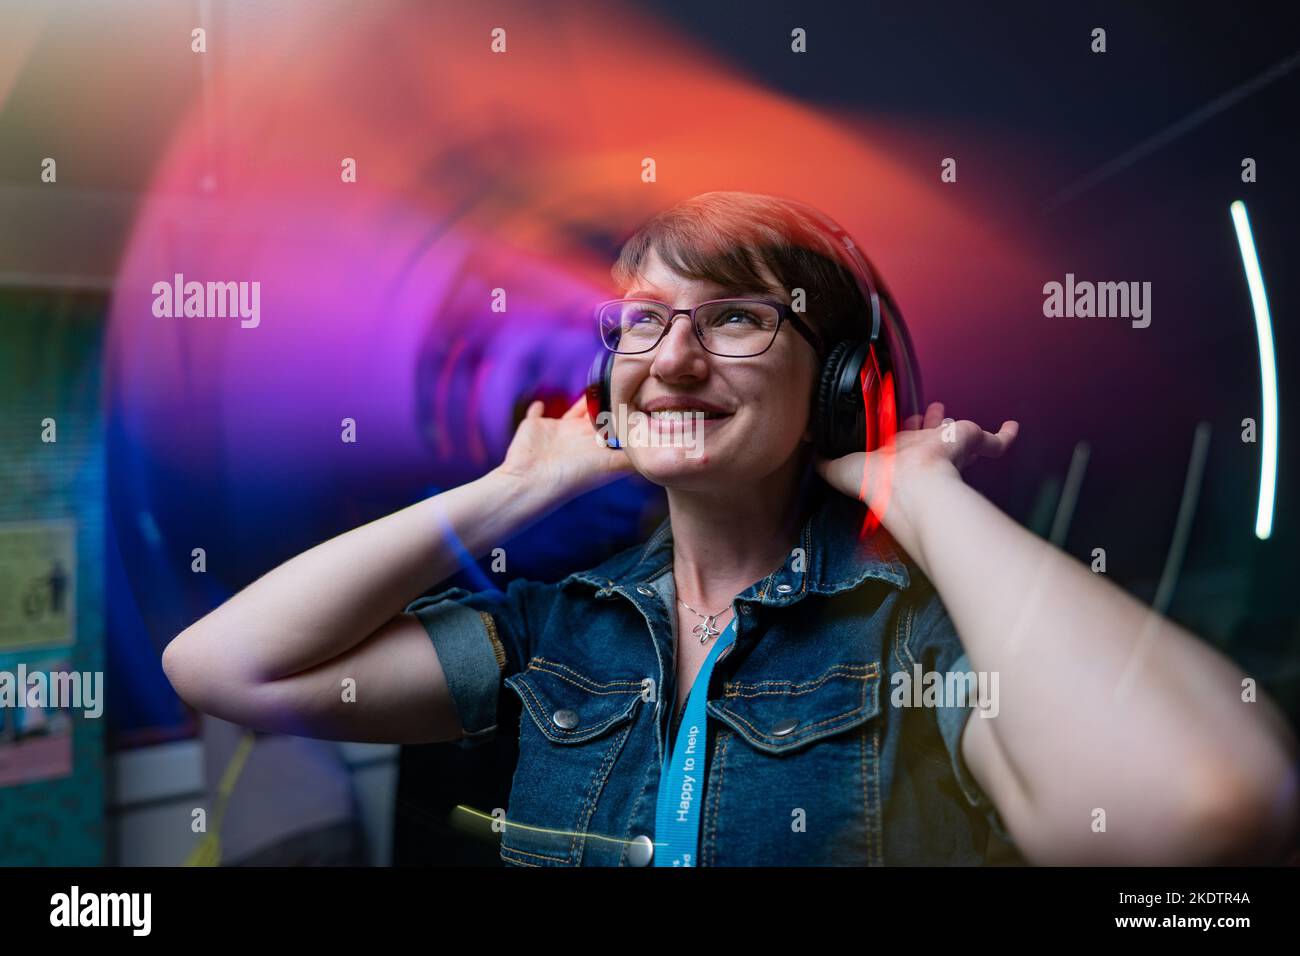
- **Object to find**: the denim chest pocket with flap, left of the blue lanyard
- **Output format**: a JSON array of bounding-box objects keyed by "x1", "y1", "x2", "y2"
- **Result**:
[{"x1": 501, "y1": 657, "x2": 642, "y2": 866}]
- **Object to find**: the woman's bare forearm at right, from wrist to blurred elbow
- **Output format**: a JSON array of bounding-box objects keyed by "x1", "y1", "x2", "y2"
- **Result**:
[{"x1": 884, "y1": 470, "x2": 1295, "y2": 858}]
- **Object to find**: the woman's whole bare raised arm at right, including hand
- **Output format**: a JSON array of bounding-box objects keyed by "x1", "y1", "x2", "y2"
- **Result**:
[{"x1": 819, "y1": 403, "x2": 1297, "y2": 865}]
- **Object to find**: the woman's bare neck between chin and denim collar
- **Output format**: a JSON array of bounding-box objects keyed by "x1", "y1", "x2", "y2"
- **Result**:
[{"x1": 668, "y1": 455, "x2": 806, "y2": 614}]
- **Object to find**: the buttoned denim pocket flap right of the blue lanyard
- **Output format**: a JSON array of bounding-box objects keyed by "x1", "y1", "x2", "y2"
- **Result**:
[{"x1": 709, "y1": 662, "x2": 880, "y2": 753}]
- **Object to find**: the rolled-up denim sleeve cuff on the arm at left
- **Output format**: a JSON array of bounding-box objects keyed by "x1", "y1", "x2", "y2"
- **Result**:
[{"x1": 406, "y1": 579, "x2": 555, "y2": 747}]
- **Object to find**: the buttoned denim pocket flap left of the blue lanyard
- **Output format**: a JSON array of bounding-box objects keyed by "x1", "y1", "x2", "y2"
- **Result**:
[{"x1": 504, "y1": 657, "x2": 644, "y2": 744}]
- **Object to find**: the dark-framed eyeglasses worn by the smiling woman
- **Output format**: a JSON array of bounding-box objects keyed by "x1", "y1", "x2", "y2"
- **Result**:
[{"x1": 595, "y1": 299, "x2": 822, "y2": 359}]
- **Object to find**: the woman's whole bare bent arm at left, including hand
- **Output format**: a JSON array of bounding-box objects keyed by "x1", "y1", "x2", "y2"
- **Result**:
[{"x1": 163, "y1": 401, "x2": 627, "y2": 743}]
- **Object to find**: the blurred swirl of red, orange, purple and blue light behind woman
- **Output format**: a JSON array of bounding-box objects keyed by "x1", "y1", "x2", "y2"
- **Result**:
[{"x1": 105, "y1": 3, "x2": 1043, "y2": 731}]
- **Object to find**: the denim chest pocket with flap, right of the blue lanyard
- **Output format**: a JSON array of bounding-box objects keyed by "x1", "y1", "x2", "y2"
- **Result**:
[{"x1": 699, "y1": 662, "x2": 883, "y2": 866}]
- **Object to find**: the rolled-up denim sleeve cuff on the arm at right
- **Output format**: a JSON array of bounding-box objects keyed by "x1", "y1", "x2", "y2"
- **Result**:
[{"x1": 906, "y1": 581, "x2": 1014, "y2": 843}]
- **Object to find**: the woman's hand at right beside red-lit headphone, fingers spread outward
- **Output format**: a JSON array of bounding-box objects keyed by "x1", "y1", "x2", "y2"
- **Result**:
[{"x1": 815, "y1": 402, "x2": 1021, "y2": 515}]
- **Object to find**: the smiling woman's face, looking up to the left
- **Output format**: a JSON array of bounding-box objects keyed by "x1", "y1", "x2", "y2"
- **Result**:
[{"x1": 610, "y1": 250, "x2": 818, "y2": 490}]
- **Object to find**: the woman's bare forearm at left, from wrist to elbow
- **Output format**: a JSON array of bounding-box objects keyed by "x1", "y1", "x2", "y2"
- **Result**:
[{"x1": 177, "y1": 471, "x2": 550, "y2": 682}]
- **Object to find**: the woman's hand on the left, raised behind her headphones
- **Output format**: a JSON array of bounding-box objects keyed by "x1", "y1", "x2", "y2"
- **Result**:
[{"x1": 497, "y1": 397, "x2": 633, "y2": 498}]
